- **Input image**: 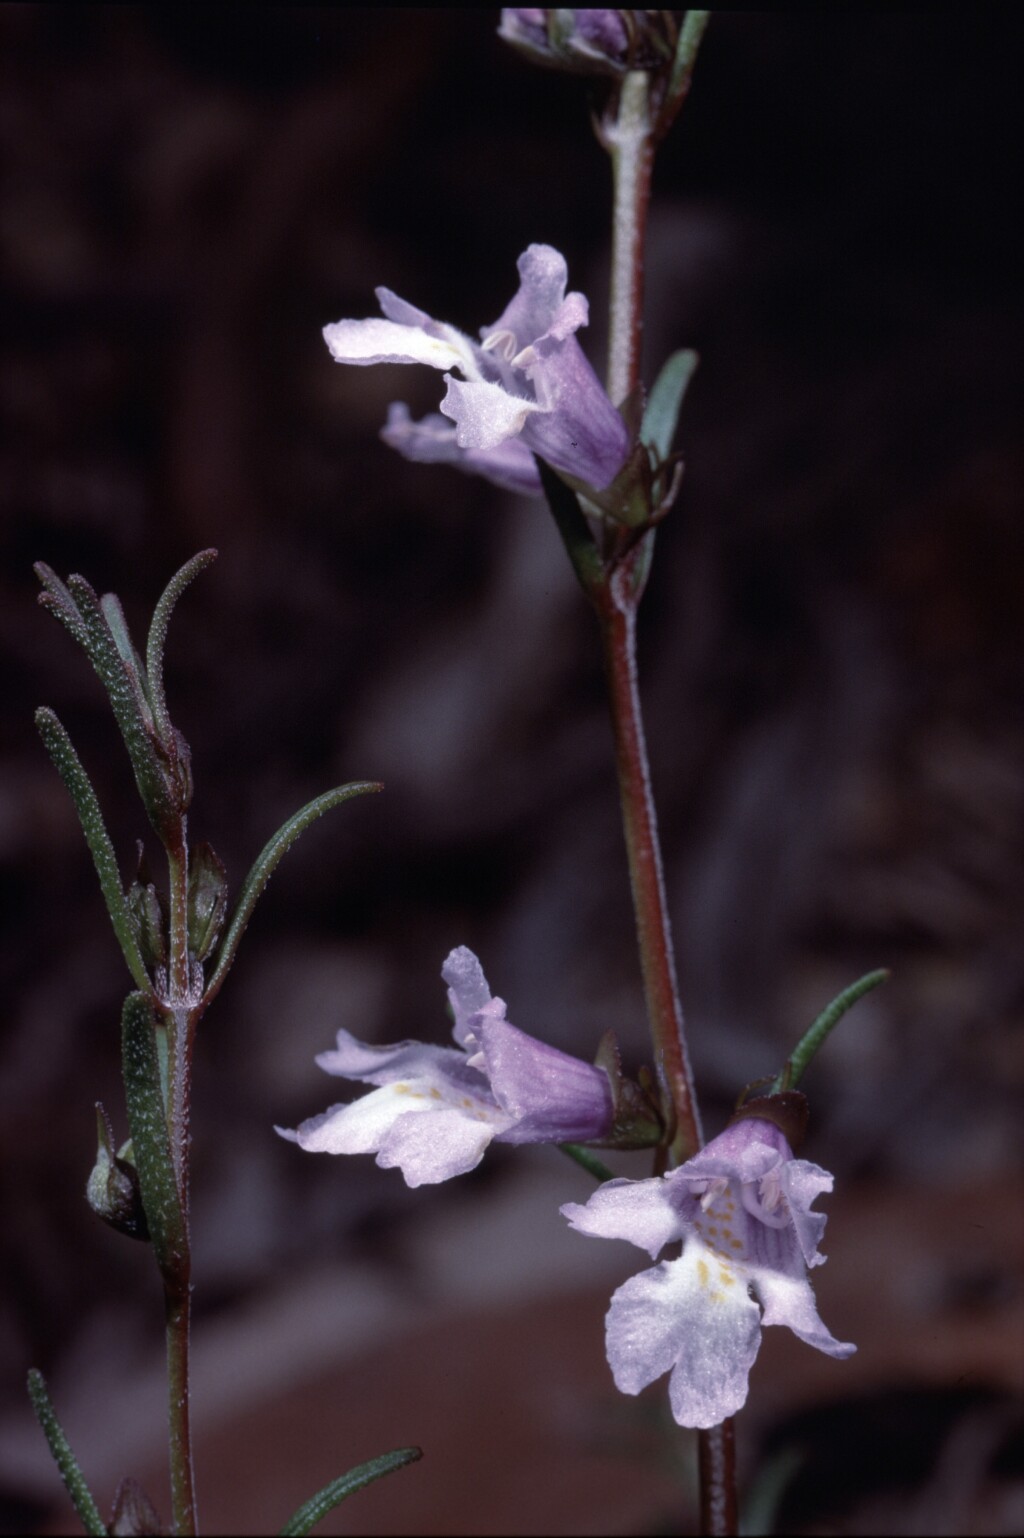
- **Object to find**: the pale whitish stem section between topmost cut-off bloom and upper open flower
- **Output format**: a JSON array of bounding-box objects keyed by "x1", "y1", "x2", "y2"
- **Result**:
[{"x1": 603, "y1": 69, "x2": 655, "y2": 406}]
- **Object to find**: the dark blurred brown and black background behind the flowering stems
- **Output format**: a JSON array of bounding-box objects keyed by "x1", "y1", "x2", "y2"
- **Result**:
[{"x1": 0, "y1": 5, "x2": 1024, "y2": 1533}]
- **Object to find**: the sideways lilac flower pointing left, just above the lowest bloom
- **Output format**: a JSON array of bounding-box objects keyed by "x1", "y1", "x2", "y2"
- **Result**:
[{"x1": 277, "y1": 946, "x2": 612, "y2": 1186}]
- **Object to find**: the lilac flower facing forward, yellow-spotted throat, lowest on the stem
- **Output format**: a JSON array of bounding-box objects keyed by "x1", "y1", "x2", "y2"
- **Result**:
[{"x1": 561, "y1": 1118, "x2": 856, "y2": 1429}]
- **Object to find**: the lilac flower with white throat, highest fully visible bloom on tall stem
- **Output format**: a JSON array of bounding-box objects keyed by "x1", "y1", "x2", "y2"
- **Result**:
[{"x1": 323, "y1": 246, "x2": 629, "y2": 495}]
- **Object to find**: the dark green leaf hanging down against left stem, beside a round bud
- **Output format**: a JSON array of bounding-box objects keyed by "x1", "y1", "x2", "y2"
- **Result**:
[{"x1": 121, "y1": 994, "x2": 188, "y2": 1277}]
